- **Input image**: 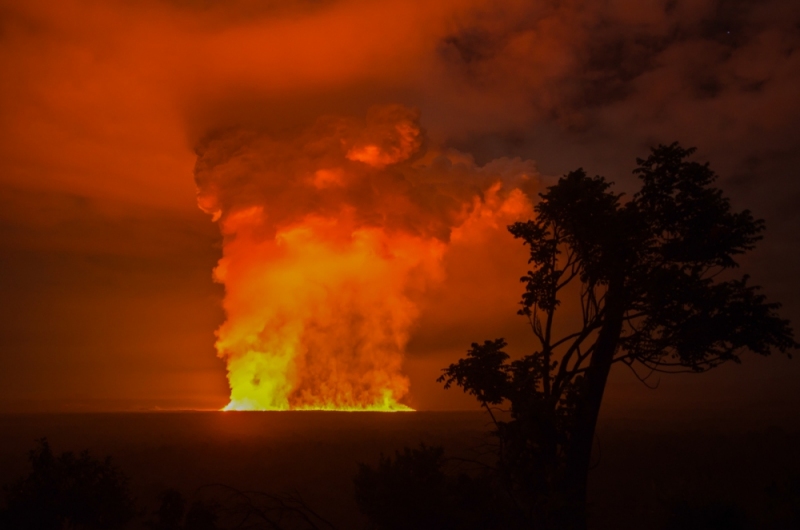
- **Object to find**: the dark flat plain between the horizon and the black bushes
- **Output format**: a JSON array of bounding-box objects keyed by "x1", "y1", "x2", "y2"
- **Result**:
[{"x1": 0, "y1": 412, "x2": 800, "y2": 530}]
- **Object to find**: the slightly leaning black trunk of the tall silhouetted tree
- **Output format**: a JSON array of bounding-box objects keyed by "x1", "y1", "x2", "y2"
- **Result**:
[{"x1": 564, "y1": 279, "x2": 625, "y2": 530}]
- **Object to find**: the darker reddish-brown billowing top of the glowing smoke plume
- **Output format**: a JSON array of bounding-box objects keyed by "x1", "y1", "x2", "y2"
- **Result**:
[{"x1": 195, "y1": 105, "x2": 538, "y2": 241}]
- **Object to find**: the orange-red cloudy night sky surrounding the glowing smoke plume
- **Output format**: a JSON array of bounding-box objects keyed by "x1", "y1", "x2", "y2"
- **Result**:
[{"x1": 0, "y1": 0, "x2": 800, "y2": 418}]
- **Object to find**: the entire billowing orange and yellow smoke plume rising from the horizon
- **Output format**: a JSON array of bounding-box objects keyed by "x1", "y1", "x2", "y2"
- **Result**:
[{"x1": 195, "y1": 105, "x2": 536, "y2": 410}]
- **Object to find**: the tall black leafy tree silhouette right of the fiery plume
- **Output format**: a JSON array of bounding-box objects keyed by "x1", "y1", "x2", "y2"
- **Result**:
[{"x1": 439, "y1": 143, "x2": 798, "y2": 529}]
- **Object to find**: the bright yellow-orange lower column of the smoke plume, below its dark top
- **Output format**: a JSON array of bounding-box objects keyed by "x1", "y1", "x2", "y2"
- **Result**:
[{"x1": 215, "y1": 209, "x2": 444, "y2": 412}]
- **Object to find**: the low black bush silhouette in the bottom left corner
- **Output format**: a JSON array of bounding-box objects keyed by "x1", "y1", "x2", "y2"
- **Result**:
[{"x1": 0, "y1": 439, "x2": 136, "y2": 530}]
